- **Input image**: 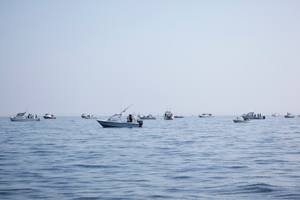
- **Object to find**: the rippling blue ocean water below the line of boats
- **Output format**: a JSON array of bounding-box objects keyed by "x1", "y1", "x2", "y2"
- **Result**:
[{"x1": 0, "y1": 116, "x2": 300, "y2": 199}]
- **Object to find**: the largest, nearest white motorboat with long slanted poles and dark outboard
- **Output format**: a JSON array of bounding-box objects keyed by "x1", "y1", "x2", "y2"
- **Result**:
[{"x1": 96, "y1": 106, "x2": 143, "y2": 128}]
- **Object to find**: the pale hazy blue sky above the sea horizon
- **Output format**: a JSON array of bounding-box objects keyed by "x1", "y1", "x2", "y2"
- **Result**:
[{"x1": 0, "y1": 0, "x2": 300, "y2": 116}]
